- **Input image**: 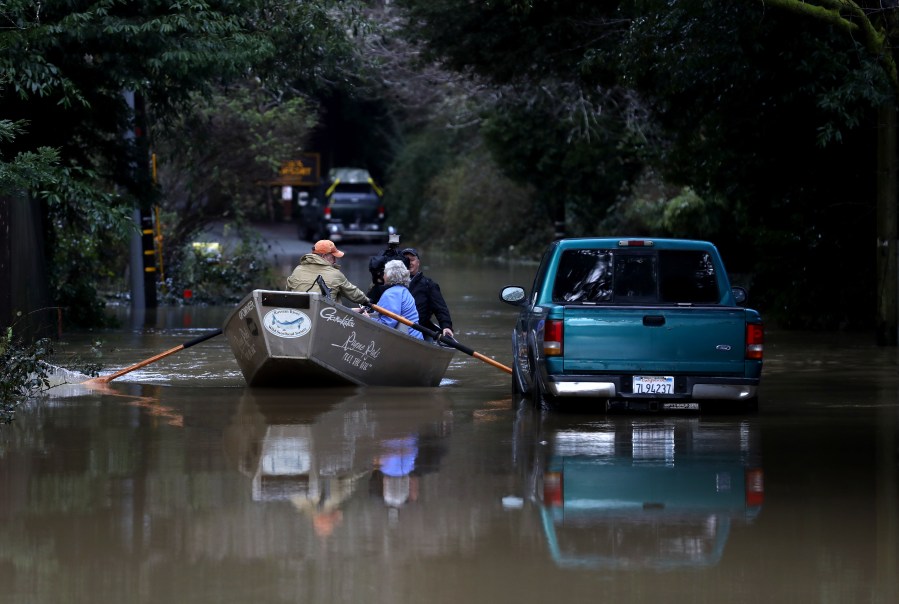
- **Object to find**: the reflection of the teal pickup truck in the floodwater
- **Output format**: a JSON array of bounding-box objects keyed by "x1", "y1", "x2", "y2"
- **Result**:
[{"x1": 531, "y1": 418, "x2": 764, "y2": 569}]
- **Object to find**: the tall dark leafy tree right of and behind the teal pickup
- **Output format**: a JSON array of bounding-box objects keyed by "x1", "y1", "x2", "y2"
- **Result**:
[{"x1": 622, "y1": 1, "x2": 891, "y2": 328}]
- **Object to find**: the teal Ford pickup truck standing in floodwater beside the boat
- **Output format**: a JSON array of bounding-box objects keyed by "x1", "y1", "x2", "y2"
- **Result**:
[{"x1": 500, "y1": 238, "x2": 764, "y2": 411}]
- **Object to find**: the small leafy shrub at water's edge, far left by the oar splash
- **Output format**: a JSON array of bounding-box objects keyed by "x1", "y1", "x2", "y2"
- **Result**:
[{"x1": 0, "y1": 327, "x2": 51, "y2": 423}]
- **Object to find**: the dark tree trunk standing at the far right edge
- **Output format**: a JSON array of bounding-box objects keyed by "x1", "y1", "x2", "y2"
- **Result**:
[{"x1": 876, "y1": 104, "x2": 899, "y2": 346}]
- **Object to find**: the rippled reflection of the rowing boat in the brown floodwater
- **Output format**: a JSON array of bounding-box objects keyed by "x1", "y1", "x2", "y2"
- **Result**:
[{"x1": 226, "y1": 388, "x2": 449, "y2": 530}]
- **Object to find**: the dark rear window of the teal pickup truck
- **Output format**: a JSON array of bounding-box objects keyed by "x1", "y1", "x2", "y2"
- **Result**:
[{"x1": 553, "y1": 249, "x2": 720, "y2": 304}]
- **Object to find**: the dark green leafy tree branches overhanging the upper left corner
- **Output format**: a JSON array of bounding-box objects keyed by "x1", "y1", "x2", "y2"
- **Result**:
[{"x1": 0, "y1": 0, "x2": 366, "y2": 330}]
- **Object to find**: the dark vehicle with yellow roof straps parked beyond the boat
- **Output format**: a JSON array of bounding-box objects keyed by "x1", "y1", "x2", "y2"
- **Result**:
[{"x1": 299, "y1": 168, "x2": 388, "y2": 242}]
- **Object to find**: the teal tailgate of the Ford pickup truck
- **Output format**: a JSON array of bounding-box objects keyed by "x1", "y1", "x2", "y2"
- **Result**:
[{"x1": 563, "y1": 306, "x2": 746, "y2": 375}]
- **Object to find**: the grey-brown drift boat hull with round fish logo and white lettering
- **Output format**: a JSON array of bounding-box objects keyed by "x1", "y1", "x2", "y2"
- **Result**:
[{"x1": 223, "y1": 290, "x2": 454, "y2": 387}]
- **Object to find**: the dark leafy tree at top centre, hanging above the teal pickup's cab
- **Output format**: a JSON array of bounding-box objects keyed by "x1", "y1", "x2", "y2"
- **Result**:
[{"x1": 399, "y1": 0, "x2": 642, "y2": 234}]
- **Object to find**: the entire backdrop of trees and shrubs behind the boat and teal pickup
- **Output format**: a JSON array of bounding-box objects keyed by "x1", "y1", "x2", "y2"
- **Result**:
[{"x1": 0, "y1": 0, "x2": 899, "y2": 412}]
